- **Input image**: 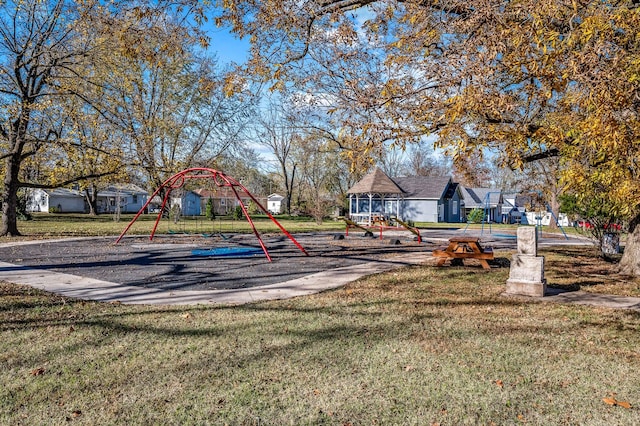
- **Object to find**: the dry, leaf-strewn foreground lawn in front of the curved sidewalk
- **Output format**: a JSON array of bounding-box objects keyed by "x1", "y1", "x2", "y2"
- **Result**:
[{"x1": 0, "y1": 240, "x2": 640, "y2": 425}]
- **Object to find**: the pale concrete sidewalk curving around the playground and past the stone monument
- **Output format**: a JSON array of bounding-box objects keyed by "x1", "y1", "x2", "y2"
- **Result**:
[{"x1": 0, "y1": 235, "x2": 640, "y2": 312}]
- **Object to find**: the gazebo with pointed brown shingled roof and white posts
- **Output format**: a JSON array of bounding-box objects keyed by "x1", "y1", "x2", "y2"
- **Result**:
[{"x1": 347, "y1": 167, "x2": 404, "y2": 226}]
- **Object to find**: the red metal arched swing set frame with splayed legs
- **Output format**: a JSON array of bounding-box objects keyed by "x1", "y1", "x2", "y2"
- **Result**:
[{"x1": 116, "y1": 167, "x2": 309, "y2": 262}]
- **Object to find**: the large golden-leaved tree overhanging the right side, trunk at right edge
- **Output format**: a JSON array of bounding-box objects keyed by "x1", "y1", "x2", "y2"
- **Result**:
[{"x1": 219, "y1": 0, "x2": 640, "y2": 275}]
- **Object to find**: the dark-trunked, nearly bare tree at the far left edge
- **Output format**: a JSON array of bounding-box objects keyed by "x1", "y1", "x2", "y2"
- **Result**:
[{"x1": 0, "y1": 0, "x2": 91, "y2": 235}]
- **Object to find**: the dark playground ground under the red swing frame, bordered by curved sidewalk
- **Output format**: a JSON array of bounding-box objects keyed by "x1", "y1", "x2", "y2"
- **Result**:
[{"x1": 0, "y1": 234, "x2": 434, "y2": 290}]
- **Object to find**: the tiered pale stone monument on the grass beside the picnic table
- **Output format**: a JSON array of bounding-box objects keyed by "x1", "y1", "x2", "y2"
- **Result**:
[{"x1": 506, "y1": 226, "x2": 547, "y2": 297}]
